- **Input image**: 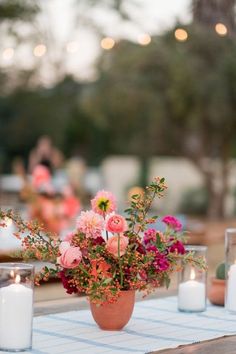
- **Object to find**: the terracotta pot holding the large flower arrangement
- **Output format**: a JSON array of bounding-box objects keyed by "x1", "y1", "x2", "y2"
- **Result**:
[{"x1": 90, "y1": 290, "x2": 135, "y2": 331}]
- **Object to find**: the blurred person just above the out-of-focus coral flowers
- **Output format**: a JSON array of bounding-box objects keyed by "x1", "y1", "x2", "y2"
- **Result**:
[{"x1": 29, "y1": 135, "x2": 63, "y2": 173}]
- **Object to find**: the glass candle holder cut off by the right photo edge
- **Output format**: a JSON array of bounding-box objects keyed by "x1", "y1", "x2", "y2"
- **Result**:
[{"x1": 225, "y1": 228, "x2": 236, "y2": 314}]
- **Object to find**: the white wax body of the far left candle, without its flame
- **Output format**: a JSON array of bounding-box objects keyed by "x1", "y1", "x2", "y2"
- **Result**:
[{"x1": 0, "y1": 284, "x2": 33, "y2": 350}]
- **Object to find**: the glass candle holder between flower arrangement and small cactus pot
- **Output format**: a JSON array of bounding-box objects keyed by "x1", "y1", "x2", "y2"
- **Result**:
[{"x1": 178, "y1": 245, "x2": 207, "y2": 312}]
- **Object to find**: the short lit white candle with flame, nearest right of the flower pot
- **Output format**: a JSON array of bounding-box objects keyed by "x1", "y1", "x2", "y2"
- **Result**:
[{"x1": 178, "y1": 269, "x2": 206, "y2": 312}]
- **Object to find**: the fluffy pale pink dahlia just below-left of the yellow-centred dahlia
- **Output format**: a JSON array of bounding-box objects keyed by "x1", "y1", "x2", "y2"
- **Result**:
[{"x1": 77, "y1": 210, "x2": 104, "y2": 238}]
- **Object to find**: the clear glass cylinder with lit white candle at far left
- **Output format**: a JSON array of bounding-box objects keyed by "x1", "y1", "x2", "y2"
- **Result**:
[{"x1": 0, "y1": 263, "x2": 34, "y2": 352}]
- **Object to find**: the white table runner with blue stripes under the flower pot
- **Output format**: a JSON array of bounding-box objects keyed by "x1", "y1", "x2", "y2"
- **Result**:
[{"x1": 1, "y1": 297, "x2": 236, "y2": 354}]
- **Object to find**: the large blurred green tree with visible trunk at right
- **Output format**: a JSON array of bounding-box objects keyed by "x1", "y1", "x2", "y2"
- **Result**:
[{"x1": 84, "y1": 27, "x2": 236, "y2": 217}]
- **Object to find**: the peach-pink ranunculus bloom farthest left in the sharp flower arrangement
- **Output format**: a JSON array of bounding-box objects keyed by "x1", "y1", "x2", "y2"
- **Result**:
[{"x1": 57, "y1": 242, "x2": 82, "y2": 269}]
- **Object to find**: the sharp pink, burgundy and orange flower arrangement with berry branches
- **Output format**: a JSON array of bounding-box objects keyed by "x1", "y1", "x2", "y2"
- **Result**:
[{"x1": 0, "y1": 178, "x2": 204, "y2": 304}]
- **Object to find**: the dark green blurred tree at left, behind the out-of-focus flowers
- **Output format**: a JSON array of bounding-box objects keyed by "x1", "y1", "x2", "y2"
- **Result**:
[{"x1": 0, "y1": 76, "x2": 106, "y2": 171}]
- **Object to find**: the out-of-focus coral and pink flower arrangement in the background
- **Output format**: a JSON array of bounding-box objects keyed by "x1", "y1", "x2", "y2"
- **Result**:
[{"x1": 25, "y1": 165, "x2": 80, "y2": 234}]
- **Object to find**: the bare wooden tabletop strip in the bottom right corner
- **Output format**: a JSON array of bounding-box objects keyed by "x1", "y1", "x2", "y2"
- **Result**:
[{"x1": 150, "y1": 336, "x2": 236, "y2": 354}]
